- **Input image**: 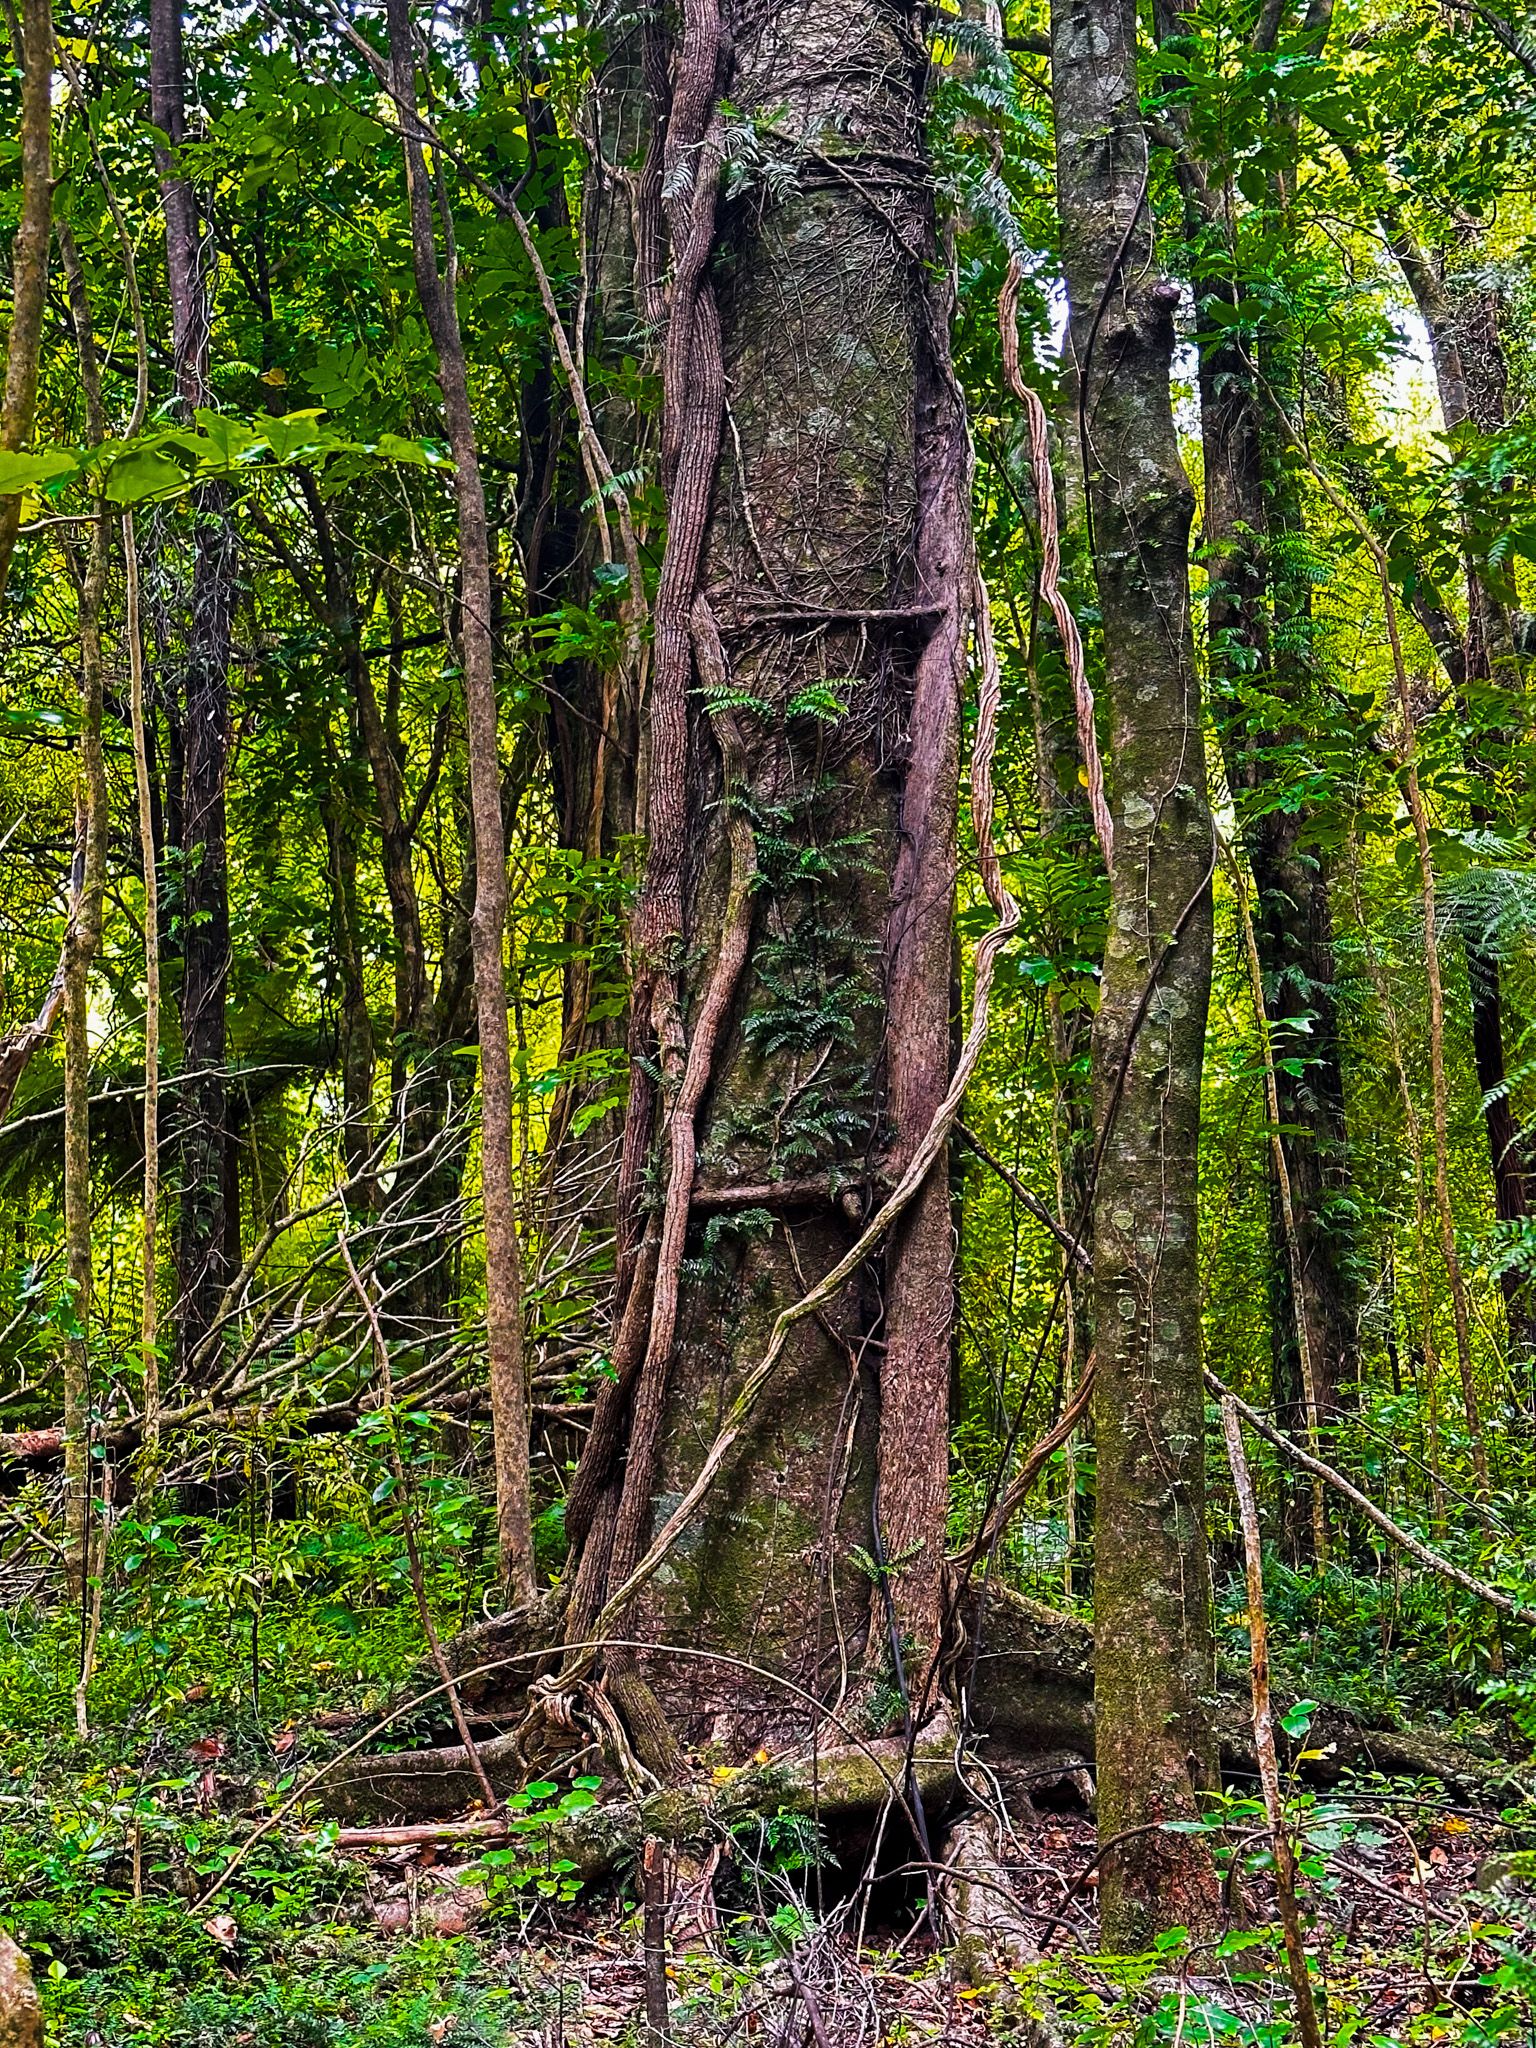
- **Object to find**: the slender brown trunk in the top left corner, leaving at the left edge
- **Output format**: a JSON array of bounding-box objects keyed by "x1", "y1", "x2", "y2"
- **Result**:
[{"x1": 0, "y1": 0, "x2": 53, "y2": 598}]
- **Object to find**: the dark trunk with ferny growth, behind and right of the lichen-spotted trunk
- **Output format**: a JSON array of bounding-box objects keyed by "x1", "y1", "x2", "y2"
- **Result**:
[{"x1": 1157, "y1": 0, "x2": 1360, "y2": 1556}]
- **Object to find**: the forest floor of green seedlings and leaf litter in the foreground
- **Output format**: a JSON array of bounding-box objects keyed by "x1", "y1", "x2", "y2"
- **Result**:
[{"x1": 0, "y1": 1556, "x2": 1536, "y2": 2048}]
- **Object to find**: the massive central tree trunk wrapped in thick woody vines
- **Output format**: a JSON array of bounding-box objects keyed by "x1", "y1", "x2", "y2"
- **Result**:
[{"x1": 567, "y1": 0, "x2": 971, "y2": 1749}]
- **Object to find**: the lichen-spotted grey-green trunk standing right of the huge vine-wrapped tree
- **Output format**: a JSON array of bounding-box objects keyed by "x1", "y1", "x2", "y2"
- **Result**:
[{"x1": 1051, "y1": 0, "x2": 1217, "y2": 1950}]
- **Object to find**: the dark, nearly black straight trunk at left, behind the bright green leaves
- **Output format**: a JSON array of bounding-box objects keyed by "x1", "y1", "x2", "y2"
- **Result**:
[{"x1": 150, "y1": 0, "x2": 236, "y2": 1374}]
